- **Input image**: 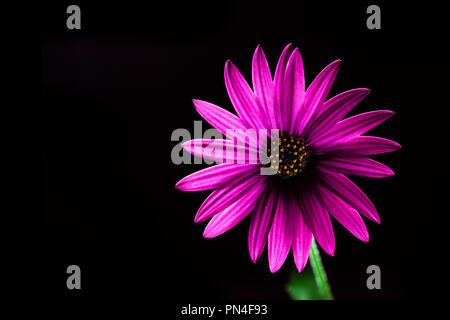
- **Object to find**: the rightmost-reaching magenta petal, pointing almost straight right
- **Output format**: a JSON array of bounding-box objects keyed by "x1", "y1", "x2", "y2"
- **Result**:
[{"x1": 315, "y1": 136, "x2": 401, "y2": 156}]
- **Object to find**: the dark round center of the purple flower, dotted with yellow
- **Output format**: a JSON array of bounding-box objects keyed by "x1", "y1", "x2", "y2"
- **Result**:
[{"x1": 267, "y1": 134, "x2": 310, "y2": 179}]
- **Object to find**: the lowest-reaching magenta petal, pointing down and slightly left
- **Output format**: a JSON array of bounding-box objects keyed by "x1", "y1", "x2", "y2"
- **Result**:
[{"x1": 268, "y1": 193, "x2": 292, "y2": 273}]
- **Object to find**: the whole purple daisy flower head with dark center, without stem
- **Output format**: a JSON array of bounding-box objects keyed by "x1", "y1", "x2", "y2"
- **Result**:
[{"x1": 176, "y1": 44, "x2": 400, "y2": 272}]
